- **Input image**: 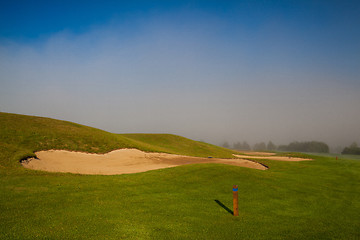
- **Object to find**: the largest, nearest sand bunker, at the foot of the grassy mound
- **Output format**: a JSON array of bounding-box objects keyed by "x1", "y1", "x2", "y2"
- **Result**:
[{"x1": 22, "y1": 149, "x2": 267, "y2": 175}]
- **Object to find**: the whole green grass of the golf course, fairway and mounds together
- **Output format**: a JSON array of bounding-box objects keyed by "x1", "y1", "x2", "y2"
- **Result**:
[{"x1": 0, "y1": 113, "x2": 360, "y2": 239}]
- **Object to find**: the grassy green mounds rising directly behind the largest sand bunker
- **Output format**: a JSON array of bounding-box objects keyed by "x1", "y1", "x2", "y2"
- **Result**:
[{"x1": 0, "y1": 113, "x2": 236, "y2": 169}]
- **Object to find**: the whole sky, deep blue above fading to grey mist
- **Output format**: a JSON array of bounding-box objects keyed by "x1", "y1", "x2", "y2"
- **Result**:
[{"x1": 0, "y1": 0, "x2": 360, "y2": 150}]
